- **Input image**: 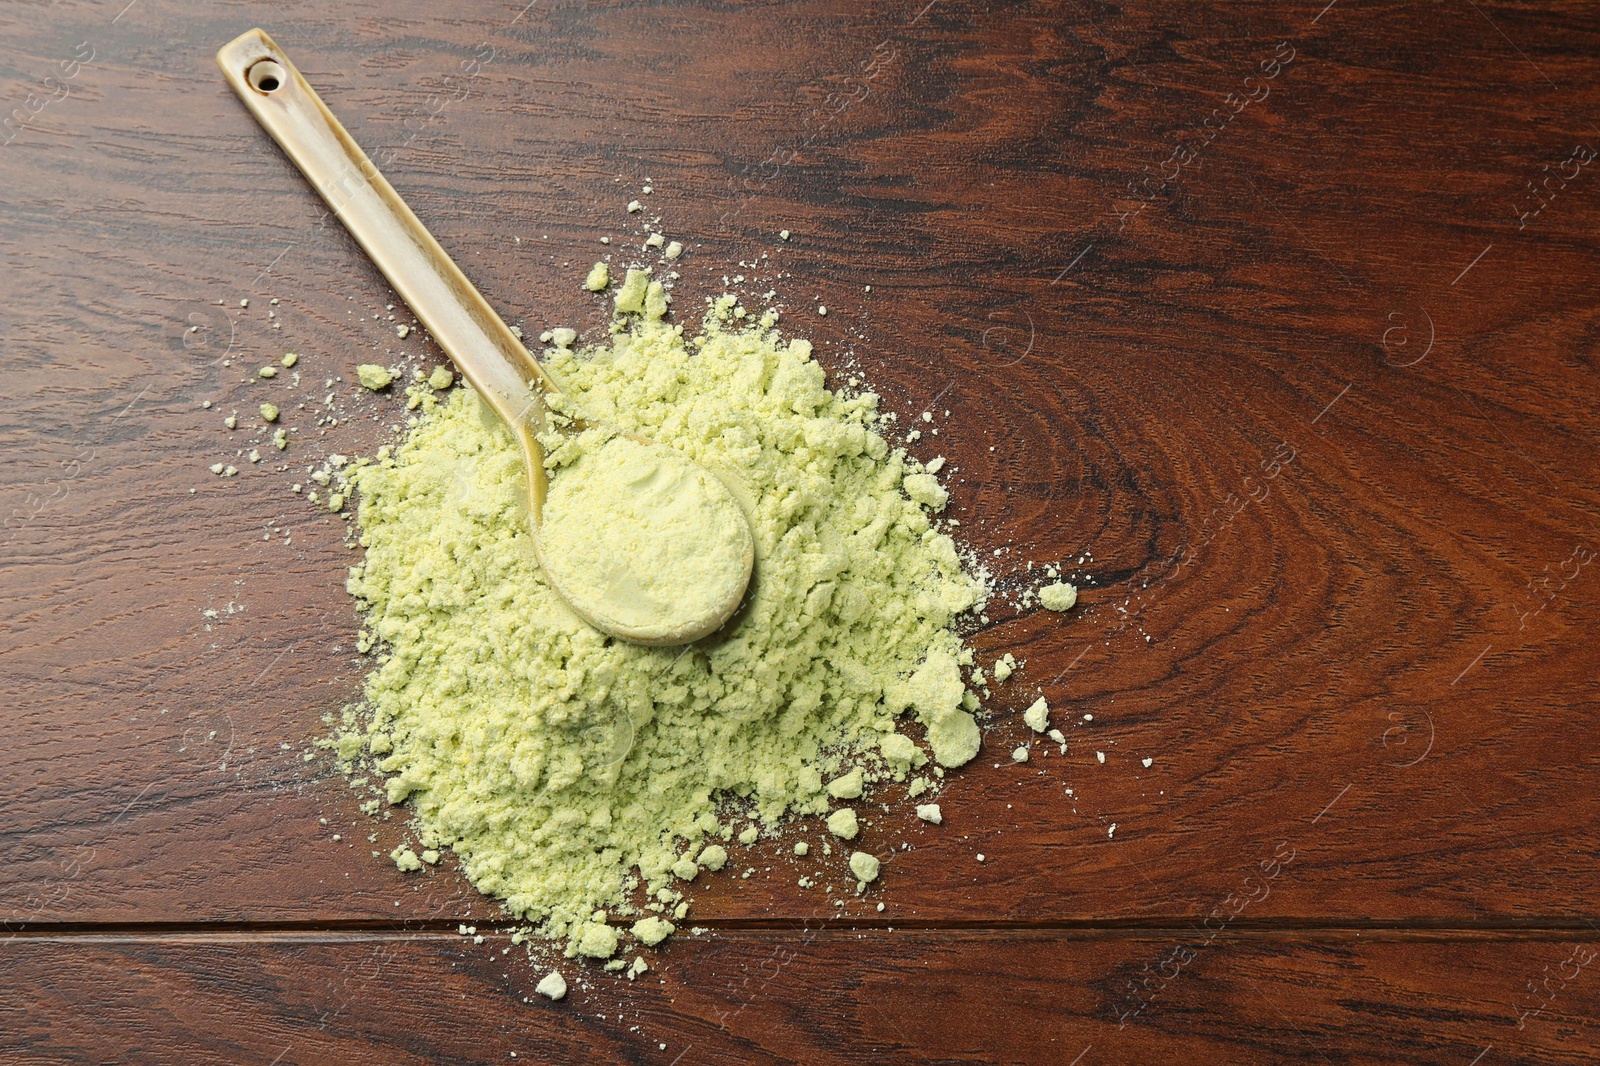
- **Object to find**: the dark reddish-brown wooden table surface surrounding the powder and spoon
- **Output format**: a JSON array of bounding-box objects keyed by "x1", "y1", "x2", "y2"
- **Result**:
[{"x1": 0, "y1": 0, "x2": 1600, "y2": 1066}]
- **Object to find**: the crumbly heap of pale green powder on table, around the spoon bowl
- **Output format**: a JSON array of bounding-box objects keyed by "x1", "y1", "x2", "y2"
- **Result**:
[{"x1": 330, "y1": 271, "x2": 986, "y2": 956}]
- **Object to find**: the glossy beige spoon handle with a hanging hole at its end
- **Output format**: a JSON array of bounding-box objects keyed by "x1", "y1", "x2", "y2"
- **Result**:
[{"x1": 216, "y1": 29, "x2": 557, "y2": 492}]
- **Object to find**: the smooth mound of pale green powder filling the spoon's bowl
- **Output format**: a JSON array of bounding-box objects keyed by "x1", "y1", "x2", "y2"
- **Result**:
[{"x1": 538, "y1": 429, "x2": 755, "y2": 643}]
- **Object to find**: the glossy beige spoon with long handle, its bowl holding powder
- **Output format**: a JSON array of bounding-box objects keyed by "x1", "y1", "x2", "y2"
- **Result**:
[{"x1": 216, "y1": 29, "x2": 755, "y2": 645}]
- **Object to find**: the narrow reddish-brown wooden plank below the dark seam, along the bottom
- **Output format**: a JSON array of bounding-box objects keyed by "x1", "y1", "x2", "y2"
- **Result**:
[{"x1": 0, "y1": 928, "x2": 1600, "y2": 1066}]
